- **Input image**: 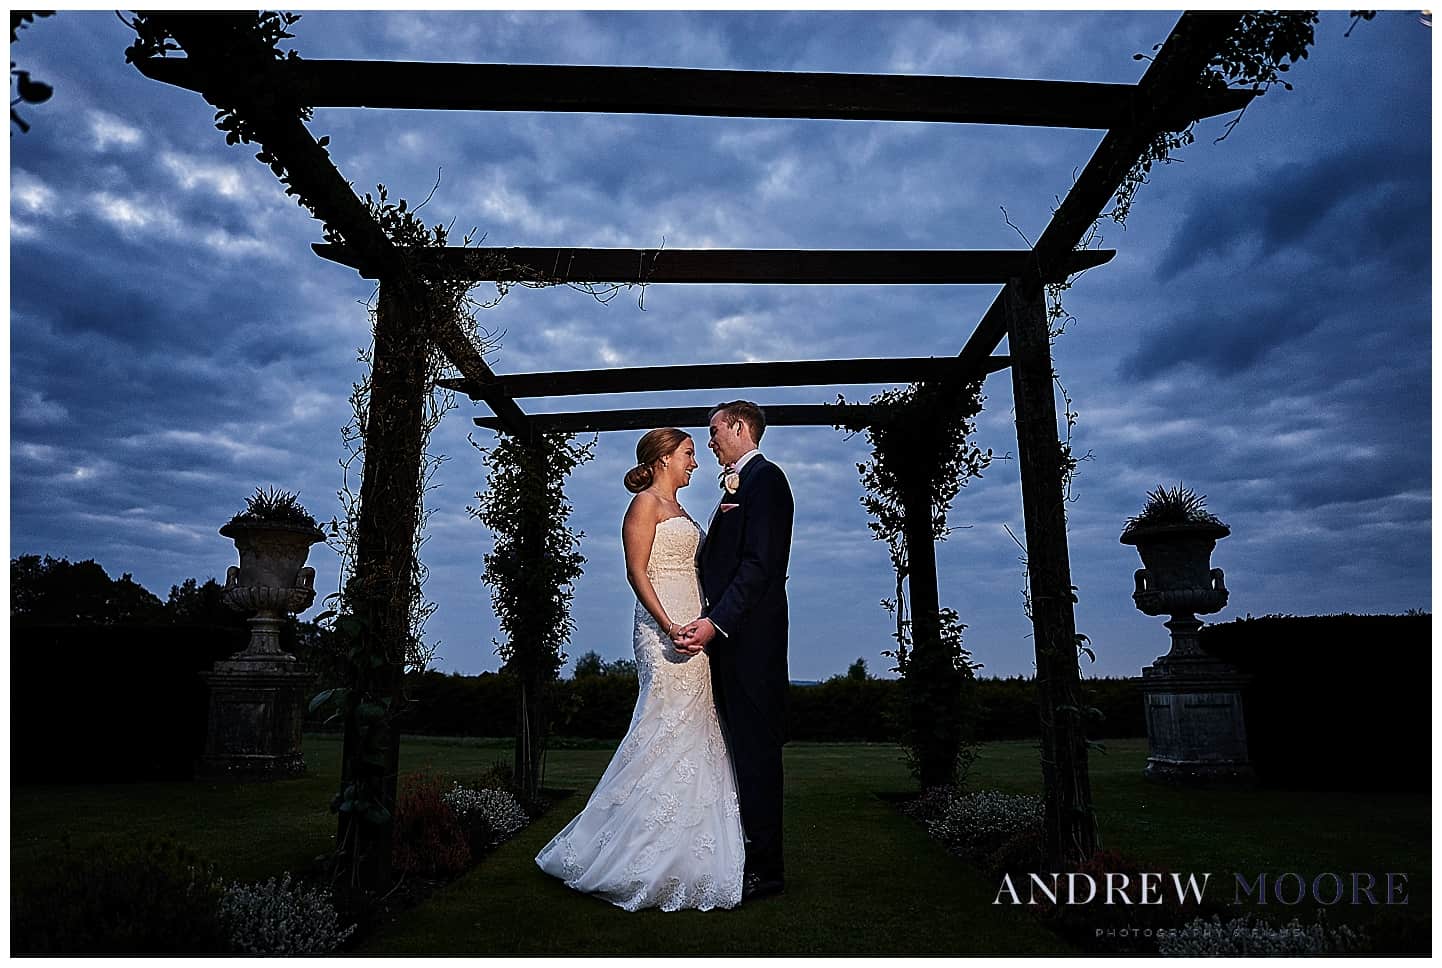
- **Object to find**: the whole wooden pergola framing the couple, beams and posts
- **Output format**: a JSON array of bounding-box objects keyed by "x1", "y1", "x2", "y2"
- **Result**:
[{"x1": 136, "y1": 13, "x2": 1255, "y2": 894}]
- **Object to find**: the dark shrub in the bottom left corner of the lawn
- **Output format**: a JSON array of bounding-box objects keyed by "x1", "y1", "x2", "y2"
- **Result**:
[{"x1": 10, "y1": 840, "x2": 225, "y2": 955}]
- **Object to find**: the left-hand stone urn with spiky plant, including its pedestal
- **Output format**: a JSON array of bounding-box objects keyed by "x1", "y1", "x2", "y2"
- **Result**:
[{"x1": 200, "y1": 490, "x2": 324, "y2": 778}]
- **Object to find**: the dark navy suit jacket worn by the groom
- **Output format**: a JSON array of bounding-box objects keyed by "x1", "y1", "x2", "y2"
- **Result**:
[{"x1": 696, "y1": 454, "x2": 796, "y2": 742}]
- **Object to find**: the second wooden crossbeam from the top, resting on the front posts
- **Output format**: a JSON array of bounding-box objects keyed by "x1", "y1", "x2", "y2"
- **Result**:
[{"x1": 311, "y1": 244, "x2": 1116, "y2": 286}]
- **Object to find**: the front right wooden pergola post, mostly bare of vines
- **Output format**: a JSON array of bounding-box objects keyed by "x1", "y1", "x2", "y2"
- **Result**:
[{"x1": 1002, "y1": 280, "x2": 1097, "y2": 870}]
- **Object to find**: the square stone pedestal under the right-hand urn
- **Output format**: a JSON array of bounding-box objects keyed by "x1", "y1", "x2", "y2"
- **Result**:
[{"x1": 1142, "y1": 616, "x2": 1253, "y2": 783}]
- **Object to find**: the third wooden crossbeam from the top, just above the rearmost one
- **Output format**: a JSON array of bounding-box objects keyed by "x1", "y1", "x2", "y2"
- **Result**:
[{"x1": 437, "y1": 356, "x2": 1009, "y2": 400}]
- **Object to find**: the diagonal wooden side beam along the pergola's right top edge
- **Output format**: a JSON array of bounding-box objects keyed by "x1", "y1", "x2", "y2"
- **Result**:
[{"x1": 959, "y1": 12, "x2": 1242, "y2": 375}]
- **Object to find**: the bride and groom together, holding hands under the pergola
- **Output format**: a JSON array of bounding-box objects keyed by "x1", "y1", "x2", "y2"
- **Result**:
[{"x1": 536, "y1": 401, "x2": 795, "y2": 910}]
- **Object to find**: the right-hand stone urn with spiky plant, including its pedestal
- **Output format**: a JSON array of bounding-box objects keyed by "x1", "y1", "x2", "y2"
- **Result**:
[{"x1": 1122, "y1": 485, "x2": 1252, "y2": 782}]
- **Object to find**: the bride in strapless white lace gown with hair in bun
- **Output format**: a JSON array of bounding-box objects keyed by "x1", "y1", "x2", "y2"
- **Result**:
[{"x1": 536, "y1": 427, "x2": 746, "y2": 910}]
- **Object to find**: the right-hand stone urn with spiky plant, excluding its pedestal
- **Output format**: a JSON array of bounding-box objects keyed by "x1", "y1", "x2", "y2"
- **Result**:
[{"x1": 1122, "y1": 483, "x2": 1231, "y2": 615}]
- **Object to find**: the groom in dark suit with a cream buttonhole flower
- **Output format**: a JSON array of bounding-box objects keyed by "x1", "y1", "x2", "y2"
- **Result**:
[{"x1": 676, "y1": 400, "x2": 795, "y2": 900}]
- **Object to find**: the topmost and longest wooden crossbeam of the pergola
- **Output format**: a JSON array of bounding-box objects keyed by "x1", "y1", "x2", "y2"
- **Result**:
[{"x1": 138, "y1": 58, "x2": 1255, "y2": 128}]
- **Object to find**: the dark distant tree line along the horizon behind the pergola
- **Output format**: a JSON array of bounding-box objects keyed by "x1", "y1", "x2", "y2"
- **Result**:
[{"x1": 10, "y1": 554, "x2": 1145, "y2": 743}]
